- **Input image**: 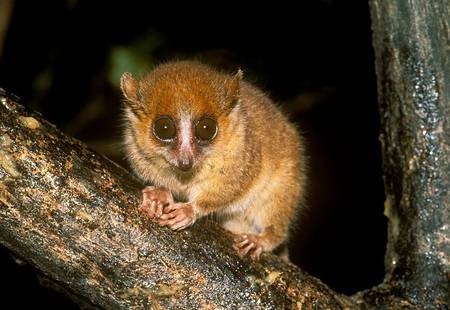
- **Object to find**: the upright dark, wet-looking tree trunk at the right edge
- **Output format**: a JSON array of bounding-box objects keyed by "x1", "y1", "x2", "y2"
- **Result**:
[{"x1": 364, "y1": 0, "x2": 450, "y2": 309}]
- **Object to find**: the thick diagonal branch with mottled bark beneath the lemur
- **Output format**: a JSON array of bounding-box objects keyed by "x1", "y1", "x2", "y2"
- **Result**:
[{"x1": 0, "y1": 88, "x2": 355, "y2": 309}]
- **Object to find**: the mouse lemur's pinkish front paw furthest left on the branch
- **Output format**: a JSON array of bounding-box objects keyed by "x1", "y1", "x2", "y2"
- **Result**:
[{"x1": 141, "y1": 186, "x2": 174, "y2": 220}]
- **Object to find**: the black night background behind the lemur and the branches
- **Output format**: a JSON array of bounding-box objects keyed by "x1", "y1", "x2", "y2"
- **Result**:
[{"x1": 0, "y1": 0, "x2": 386, "y2": 309}]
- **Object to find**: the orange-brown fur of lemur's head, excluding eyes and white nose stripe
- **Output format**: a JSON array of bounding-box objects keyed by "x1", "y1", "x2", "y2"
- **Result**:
[{"x1": 122, "y1": 61, "x2": 242, "y2": 182}]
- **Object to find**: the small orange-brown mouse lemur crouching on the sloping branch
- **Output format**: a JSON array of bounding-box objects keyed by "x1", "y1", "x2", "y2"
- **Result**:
[{"x1": 121, "y1": 61, "x2": 305, "y2": 259}]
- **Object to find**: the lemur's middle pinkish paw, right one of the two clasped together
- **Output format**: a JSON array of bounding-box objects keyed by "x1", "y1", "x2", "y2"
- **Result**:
[{"x1": 158, "y1": 202, "x2": 196, "y2": 230}]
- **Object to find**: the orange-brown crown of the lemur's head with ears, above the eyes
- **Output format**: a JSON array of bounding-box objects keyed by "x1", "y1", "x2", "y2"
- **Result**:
[{"x1": 122, "y1": 61, "x2": 242, "y2": 117}]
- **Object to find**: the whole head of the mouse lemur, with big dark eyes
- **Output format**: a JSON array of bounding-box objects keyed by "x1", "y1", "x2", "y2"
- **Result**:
[{"x1": 121, "y1": 61, "x2": 242, "y2": 174}]
